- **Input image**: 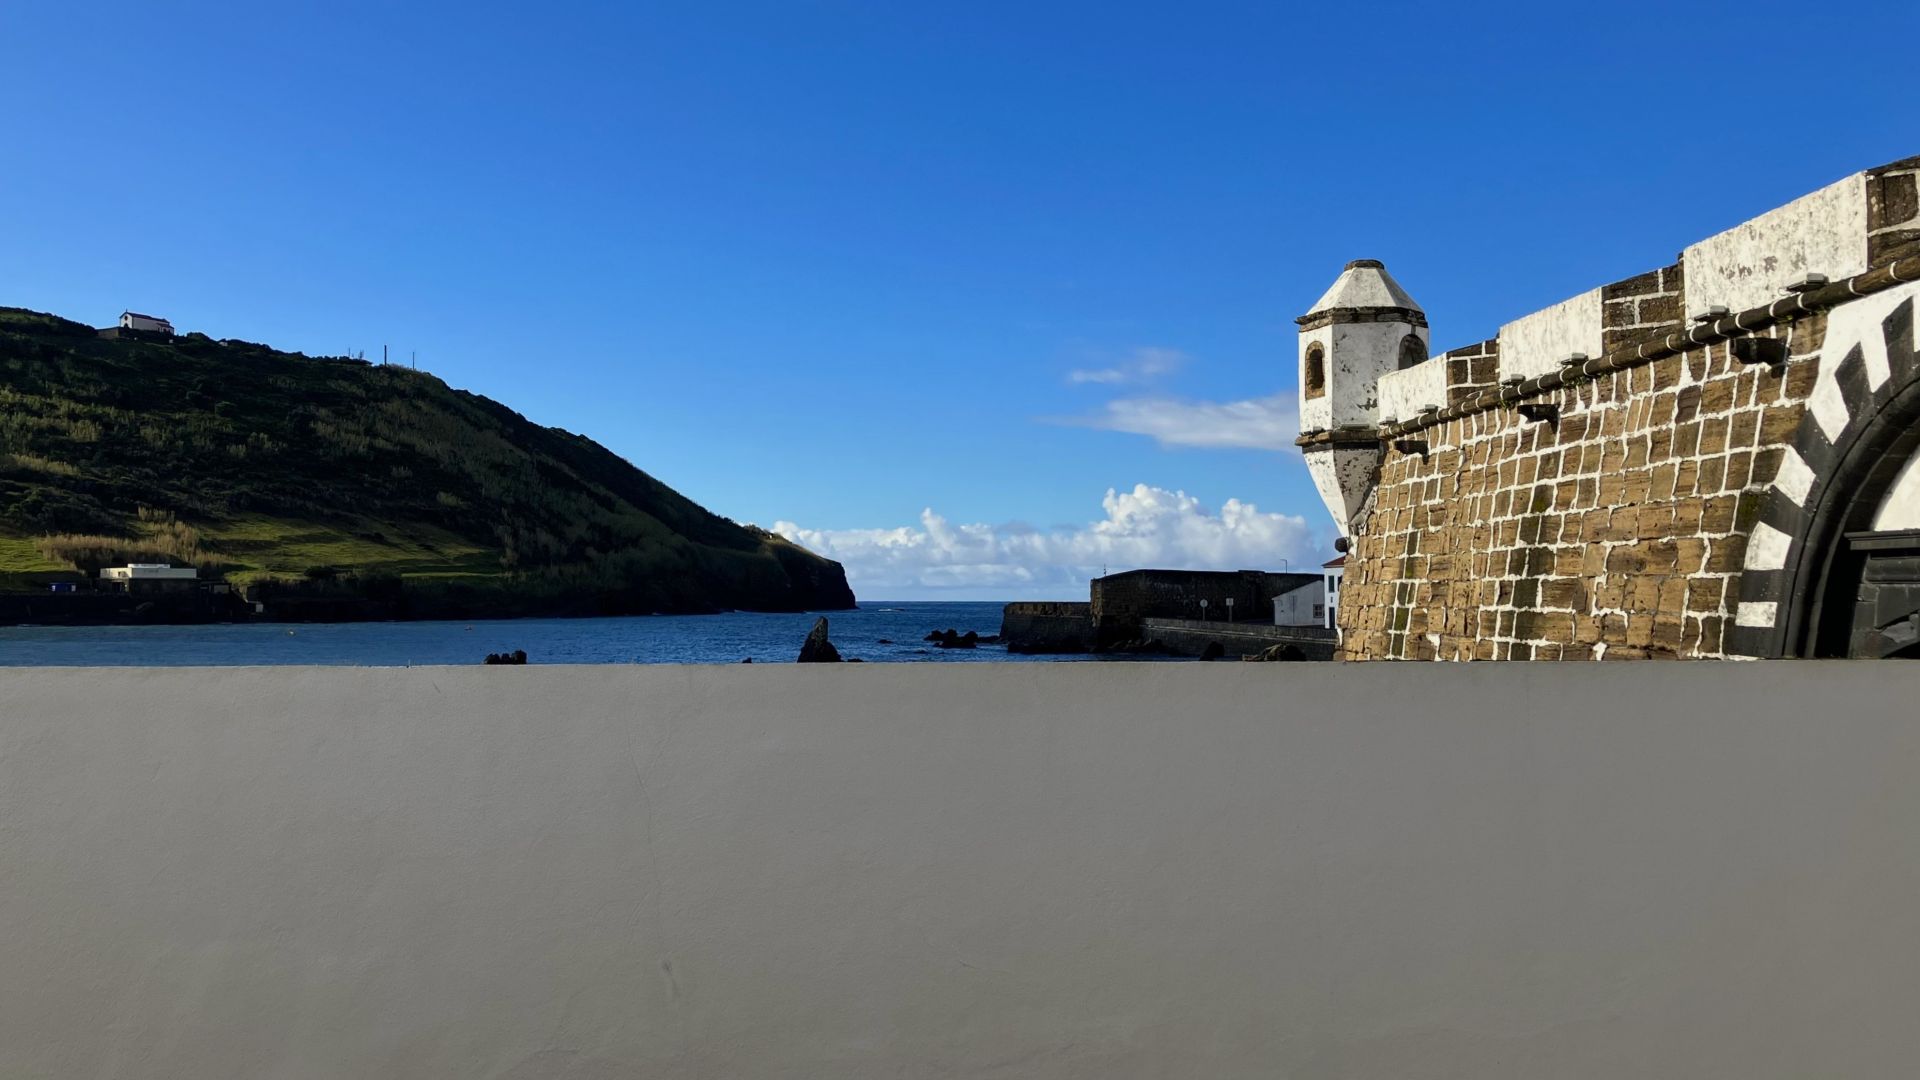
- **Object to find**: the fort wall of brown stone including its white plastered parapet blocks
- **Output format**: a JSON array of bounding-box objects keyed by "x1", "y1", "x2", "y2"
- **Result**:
[{"x1": 1300, "y1": 158, "x2": 1920, "y2": 659}]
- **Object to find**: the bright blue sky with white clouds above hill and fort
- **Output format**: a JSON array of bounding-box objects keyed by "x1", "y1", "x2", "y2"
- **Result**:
[{"x1": 0, "y1": 2, "x2": 1920, "y2": 598}]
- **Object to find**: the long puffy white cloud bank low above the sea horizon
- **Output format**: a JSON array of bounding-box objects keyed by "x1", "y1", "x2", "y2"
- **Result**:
[{"x1": 774, "y1": 484, "x2": 1319, "y2": 600}]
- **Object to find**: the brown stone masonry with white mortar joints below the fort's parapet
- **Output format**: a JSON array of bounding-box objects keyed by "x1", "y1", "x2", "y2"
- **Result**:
[{"x1": 1340, "y1": 315, "x2": 1826, "y2": 659}]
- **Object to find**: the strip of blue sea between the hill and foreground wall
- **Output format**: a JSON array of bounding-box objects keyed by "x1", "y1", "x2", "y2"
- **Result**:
[{"x1": 0, "y1": 601, "x2": 1121, "y2": 667}]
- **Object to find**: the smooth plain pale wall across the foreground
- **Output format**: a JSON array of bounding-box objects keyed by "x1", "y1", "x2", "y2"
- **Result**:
[{"x1": 0, "y1": 663, "x2": 1920, "y2": 1080}]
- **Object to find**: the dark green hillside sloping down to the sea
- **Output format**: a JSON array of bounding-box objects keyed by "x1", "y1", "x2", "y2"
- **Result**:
[{"x1": 0, "y1": 307, "x2": 852, "y2": 615}]
